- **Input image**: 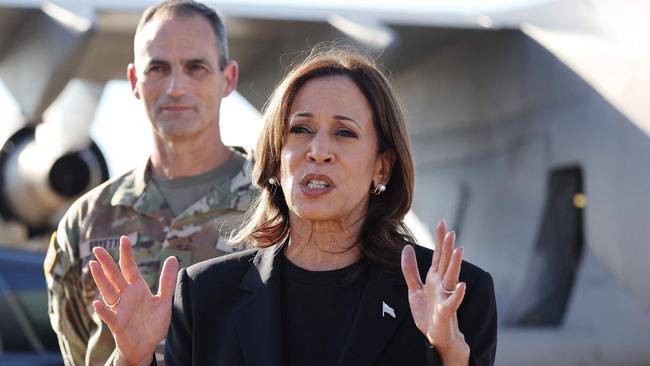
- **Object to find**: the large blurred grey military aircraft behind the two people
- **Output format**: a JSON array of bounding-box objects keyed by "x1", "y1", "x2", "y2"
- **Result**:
[{"x1": 0, "y1": 0, "x2": 650, "y2": 365}]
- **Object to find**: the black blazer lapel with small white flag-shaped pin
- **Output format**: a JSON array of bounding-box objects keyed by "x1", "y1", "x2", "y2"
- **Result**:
[{"x1": 339, "y1": 266, "x2": 410, "y2": 366}]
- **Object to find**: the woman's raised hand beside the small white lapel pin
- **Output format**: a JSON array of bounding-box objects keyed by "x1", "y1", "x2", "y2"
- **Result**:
[{"x1": 402, "y1": 221, "x2": 469, "y2": 365}]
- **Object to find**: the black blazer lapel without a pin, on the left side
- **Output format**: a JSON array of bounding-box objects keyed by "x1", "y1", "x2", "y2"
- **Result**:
[{"x1": 237, "y1": 245, "x2": 283, "y2": 366}]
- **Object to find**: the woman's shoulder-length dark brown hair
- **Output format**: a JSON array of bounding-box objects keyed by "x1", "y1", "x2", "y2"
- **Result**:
[{"x1": 233, "y1": 47, "x2": 415, "y2": 266}]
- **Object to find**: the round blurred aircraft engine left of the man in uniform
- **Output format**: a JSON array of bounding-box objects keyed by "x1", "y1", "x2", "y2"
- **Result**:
[{"x1": 0, "y1": 127, "x2": 108, "y2": 235}]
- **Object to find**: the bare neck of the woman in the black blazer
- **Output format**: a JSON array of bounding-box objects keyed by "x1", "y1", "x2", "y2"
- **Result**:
[{"x1": 285, "y1": 219, "x2": 362, "y2": 271}]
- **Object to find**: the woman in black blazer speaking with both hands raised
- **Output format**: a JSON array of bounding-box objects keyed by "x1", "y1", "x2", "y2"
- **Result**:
[{"x1": 90, "y1": 49, "x2": 496, "y2": 365}]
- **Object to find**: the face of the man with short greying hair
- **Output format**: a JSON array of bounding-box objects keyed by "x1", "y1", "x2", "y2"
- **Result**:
[{"x1": 128, "y1": 15, "x2": 237, "y2": 140}]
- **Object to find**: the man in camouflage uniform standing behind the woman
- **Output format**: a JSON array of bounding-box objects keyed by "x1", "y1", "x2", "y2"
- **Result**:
[{"x1": 44, "y1": 0, "x2": 253, "y2": 365}]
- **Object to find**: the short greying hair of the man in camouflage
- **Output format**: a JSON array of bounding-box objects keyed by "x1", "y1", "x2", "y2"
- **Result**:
[{"x1": 135, "y1": 0, "x2": 230, "y2": 71}]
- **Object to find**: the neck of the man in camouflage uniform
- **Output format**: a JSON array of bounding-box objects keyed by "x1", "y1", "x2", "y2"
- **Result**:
[{"x1": 151, "y1": 124, "x2": 232, "y2": 179}]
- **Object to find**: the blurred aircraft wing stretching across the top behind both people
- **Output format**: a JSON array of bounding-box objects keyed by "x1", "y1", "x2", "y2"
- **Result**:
[{"x1": 0, "y1": 0, "x2": 590, "y2": 116}]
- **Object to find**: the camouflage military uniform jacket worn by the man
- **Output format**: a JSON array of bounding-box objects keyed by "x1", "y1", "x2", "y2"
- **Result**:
[{"x1": 45, "y1": 152, "x2": 254, "y2": 365}]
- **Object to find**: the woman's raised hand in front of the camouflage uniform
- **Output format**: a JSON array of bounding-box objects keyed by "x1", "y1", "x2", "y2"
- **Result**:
[{"x1": 89, "y1": 236, "x2": 179, "y2": 365}]
